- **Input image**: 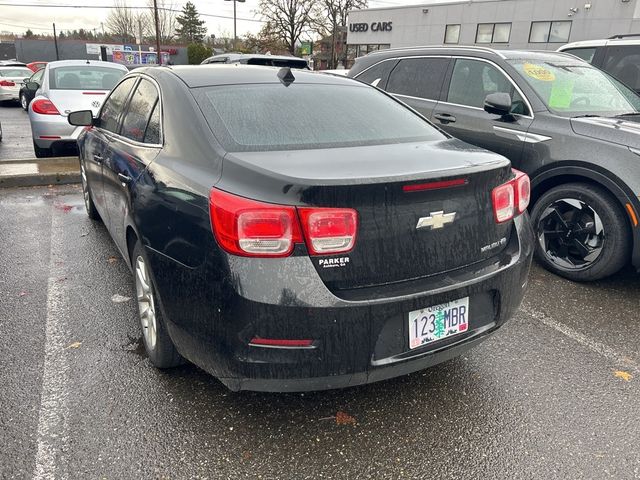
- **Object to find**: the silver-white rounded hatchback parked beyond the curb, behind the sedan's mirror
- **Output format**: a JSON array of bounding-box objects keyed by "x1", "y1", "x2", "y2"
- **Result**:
[{"x1": 29, "y1": 60, "x2": 128, "y2": 158}]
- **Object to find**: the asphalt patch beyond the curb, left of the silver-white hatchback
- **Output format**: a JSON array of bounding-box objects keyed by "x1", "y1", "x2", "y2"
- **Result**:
[{"x1": 0, "y1": 102, "x2": 35, "y2": 162}]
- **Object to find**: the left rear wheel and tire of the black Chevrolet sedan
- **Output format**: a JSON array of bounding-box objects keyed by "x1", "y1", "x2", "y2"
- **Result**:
[{"x1": 131, "y1": 240, "x2": 184, "y2": 369}]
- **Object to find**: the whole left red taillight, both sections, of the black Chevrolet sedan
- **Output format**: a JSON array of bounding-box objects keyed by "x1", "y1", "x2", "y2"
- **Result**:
[{"x1": 209, "y1": 188, "x2": 358, "y2": 257}]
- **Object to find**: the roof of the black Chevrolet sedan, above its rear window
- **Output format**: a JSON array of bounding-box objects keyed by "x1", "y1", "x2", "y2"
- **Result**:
[{"x1": 147, "y1": 64, "x2": 362, "y2": 88}]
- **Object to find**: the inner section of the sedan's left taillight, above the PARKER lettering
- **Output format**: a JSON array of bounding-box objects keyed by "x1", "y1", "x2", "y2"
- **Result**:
[{"x1": 298, "y1": 208, "x2": 358, "y2": 255}]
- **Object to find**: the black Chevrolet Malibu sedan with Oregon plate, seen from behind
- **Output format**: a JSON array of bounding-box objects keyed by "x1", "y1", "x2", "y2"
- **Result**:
[{"x1": 69, "y1": 66, "x2": 533, "y2": 391}]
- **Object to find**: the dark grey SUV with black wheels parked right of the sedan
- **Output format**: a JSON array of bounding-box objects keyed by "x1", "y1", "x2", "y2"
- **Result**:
[{"x1": 349, "y1": 47, "x2": 640, "y2": 281}]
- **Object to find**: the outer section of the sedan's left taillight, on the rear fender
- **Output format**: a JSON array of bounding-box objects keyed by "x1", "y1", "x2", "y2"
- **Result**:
[{"x1": 209, "y1": 188, "x2": 302, "y2": 257}]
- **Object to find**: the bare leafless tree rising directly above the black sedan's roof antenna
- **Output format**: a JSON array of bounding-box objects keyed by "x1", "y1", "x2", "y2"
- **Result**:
[{"x1": 258, "y1": 0, "x2": 316, "y2": 55}]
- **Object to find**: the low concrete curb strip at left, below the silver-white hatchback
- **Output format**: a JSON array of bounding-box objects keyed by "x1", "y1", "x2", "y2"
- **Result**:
[{"x1": 0, "y1": 157, "x2": 81, "y2": 188}]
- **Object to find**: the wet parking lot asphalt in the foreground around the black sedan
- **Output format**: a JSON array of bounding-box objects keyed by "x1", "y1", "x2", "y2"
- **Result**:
[{"x1": 0, "y1": 183, "x2": 640, "y2": 479}]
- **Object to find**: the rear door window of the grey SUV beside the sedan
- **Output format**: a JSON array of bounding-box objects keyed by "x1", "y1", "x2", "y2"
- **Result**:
[{"x1": 387, "y1": 58, "x2": 449, "y2": 100}]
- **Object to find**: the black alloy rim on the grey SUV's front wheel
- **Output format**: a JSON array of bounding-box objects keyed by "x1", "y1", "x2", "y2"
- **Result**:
[{"x1": 538, "y1": 198, "x2": 604, "y2": 271}]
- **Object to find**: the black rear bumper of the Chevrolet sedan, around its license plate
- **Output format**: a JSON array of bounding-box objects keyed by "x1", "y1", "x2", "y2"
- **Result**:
[{"x1": 148, "y1": 214, "x2": 533, "y2": 392}]
